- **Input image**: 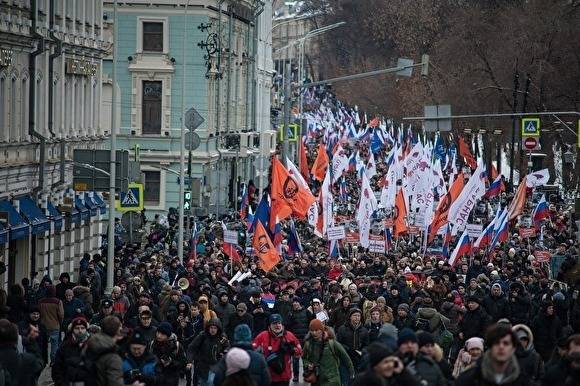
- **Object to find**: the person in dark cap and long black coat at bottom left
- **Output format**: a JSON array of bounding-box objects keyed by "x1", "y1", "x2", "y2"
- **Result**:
[{"x1": 51, "y1": 316, "x2": 90, "y2": 386}]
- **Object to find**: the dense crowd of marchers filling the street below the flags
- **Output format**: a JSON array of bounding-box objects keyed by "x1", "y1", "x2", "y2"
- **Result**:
[{"x1": 0, "y1": 88, "x2": 580, "y2": 386}]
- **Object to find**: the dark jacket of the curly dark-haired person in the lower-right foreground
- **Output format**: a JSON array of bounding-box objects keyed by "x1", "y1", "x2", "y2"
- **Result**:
[{"x1": 455, "y1": 351, "x2": 529, "y2": 386}]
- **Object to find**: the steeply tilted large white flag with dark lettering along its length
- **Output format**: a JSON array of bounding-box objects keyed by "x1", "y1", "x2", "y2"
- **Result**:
[{"x1": 447, "y1": 163, "x2": 486, "y2": 229}]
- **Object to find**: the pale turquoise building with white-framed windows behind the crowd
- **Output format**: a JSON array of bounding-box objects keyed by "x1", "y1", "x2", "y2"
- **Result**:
[{"x1": 102, "y1": 0, "x2": 275, "y2": 216}]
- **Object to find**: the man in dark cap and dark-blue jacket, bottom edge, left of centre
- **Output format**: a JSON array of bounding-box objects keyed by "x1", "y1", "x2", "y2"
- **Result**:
[{"x1": 123, "y1": 332, "x2": 157, "y2": 386}]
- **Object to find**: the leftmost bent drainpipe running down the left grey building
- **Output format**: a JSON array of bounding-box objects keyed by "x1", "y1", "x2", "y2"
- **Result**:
[{"x1": 28, "y1": 0, "x2": 46, "y2": 194}]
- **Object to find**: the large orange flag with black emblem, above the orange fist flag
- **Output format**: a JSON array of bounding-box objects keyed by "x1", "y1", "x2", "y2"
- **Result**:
[{"x1": 270, "y1": 157, "x2": 316, "y2": 224}]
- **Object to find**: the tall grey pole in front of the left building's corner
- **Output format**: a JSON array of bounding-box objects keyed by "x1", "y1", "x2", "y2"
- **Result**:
[{"x1": 105, "y1": 0, "x2": 119, "y2": 294}]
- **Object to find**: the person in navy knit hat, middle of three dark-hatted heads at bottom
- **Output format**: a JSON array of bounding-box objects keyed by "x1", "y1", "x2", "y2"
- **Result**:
[{"x1": 397, "y1": 329, "x2": 447, "y2": 386}]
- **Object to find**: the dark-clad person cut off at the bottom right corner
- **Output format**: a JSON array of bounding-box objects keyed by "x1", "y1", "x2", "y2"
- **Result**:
[{"x1": 542, "y1": 334, "x2": 580, "y2": 386}]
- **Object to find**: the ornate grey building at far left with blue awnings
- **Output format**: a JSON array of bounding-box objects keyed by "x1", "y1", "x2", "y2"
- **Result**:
[{"x1": 0, "y1": 0, "x2": 111, "y2": 286}]
